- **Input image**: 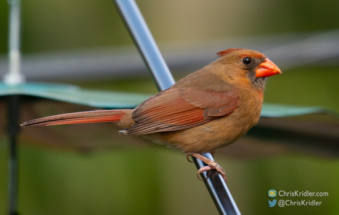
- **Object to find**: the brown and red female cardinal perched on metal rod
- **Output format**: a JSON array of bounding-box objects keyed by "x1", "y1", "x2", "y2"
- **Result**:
[{"x1": 21, "y1": 48, "x2": 282, "y2": 180}]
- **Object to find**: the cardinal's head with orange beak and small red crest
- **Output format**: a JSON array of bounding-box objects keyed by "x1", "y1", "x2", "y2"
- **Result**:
[{"x1": 217, "y1": 49, "x2": 281, "y2": 89}]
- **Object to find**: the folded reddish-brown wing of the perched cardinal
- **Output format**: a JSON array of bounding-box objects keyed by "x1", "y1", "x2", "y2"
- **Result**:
[{"x1": 127, "y1": 88, "x2": 238, "y2": 135}]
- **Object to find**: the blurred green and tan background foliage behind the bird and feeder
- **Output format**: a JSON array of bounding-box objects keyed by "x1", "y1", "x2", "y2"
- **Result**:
[{"x1": 0, "y1": 0, "x2": 339, "y2": 215}]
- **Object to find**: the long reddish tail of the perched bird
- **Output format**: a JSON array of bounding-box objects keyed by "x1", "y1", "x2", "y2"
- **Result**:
[{"x1": 21, "y1": 109, "x2": 132, "y2": 127}]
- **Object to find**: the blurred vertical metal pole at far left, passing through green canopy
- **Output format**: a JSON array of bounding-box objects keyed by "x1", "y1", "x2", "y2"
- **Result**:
[{"x1": 3, "y1": 0, "x2": 25, "y2": 215}]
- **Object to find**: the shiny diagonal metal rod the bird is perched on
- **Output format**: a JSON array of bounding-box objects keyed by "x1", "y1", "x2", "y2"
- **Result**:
[{"x1": 115, "y1": 0, "x2": 240, "y2": 215}]
